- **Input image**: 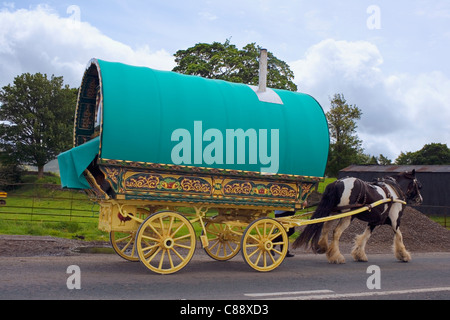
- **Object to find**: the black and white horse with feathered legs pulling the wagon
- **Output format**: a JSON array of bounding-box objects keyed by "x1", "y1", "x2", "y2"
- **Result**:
[{"x1": 293, "y1": 170, "x2": 423, "y2": 264}]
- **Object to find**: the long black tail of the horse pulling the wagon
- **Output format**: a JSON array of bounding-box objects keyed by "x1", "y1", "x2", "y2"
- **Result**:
[{"x1": 292, "y1": 181, "x2": 341, "y2": 253}]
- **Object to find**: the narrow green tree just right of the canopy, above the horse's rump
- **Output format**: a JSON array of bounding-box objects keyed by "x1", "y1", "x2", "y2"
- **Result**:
[{"x1": 326, "y1": 94, "x2": 364, "y2": 176}]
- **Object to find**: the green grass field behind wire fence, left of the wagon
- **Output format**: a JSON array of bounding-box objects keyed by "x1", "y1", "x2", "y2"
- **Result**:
[{"x1": 0, "y1": 175, "x2": 108, "y2": 241}]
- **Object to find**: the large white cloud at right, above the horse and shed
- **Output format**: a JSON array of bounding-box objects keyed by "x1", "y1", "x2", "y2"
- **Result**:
[{"x1": 290, "y1": 39, "x2": 450, "y2": 160}]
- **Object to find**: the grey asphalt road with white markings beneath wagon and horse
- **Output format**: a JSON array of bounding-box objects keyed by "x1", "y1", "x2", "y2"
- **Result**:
[{"x1": 0, "y1": 249, "x2": 450, "y2": 300}]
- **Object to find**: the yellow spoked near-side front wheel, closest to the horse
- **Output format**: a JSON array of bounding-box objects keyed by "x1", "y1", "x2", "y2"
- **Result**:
[{"x1": 241, "y1": 218, "x2": 288, "y2": 272}]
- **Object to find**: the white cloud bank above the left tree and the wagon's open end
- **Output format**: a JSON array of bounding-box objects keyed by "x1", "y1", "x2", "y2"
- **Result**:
[{"x1": 0, "y1": 6, "x2": 175, "y2": 86}]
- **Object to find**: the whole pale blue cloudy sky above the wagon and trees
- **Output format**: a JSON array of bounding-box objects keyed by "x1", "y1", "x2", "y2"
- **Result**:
[{"x1": 0, "y1": 0, "x2": 450, "y2": 160}]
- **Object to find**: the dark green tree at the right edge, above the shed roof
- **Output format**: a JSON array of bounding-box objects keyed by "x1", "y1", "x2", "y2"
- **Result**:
[{"x1": 395, "y1": 143, "x2": 450, "y2": 165}]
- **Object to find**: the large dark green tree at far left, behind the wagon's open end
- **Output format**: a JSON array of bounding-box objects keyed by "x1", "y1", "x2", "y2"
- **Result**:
[{"x1": 0, "y1": 73, "x2": 77, "y2": 177}]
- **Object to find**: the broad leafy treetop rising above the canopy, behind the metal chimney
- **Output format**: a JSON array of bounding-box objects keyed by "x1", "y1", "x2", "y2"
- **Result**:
[{"x1": 173, "y1": 40, "x2": 297, "y2": 91}]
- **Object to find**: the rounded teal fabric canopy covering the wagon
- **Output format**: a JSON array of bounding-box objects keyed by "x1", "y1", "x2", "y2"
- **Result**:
[{"x1": 59, "y1": 59, "x2": 329, "y2": 188}]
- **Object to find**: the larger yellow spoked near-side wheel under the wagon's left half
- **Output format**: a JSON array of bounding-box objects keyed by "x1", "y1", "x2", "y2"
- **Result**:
[{"x1": 136, "y1": 211, "x2": 196, "y2": 274}]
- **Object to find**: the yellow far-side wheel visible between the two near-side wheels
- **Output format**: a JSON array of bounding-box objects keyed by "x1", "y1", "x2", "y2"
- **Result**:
[{"x1": 203, "y1": 217, "x2": 244, "y2": 261}]
